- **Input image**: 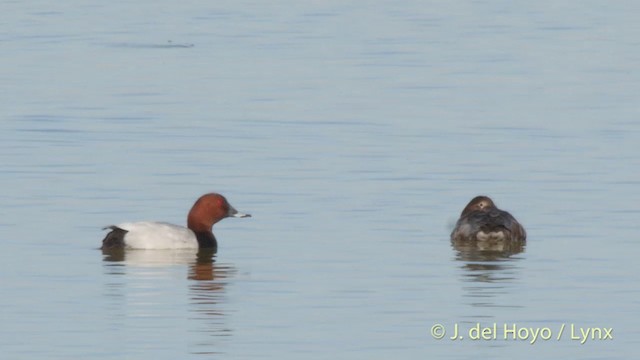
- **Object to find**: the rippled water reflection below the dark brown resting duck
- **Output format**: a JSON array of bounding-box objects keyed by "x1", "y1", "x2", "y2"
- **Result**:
[{"x1": 452, "y1": 241, "x2": 525, "y2": 315}]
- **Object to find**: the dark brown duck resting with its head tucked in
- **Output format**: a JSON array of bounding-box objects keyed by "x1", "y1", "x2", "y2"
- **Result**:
[{"x1": 451, "y1": 195, "x2": 527, "y2": 243}]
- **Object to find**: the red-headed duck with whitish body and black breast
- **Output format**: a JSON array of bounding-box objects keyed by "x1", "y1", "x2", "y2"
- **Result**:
[{"x1": 101, "y1": 193, "x2": 251, "y2": 251}]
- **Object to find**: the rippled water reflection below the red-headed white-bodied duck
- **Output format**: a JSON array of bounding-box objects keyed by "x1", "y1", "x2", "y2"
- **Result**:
[{"x1": 102, "y1": 249, "x2": 235, "y2": 354}]
